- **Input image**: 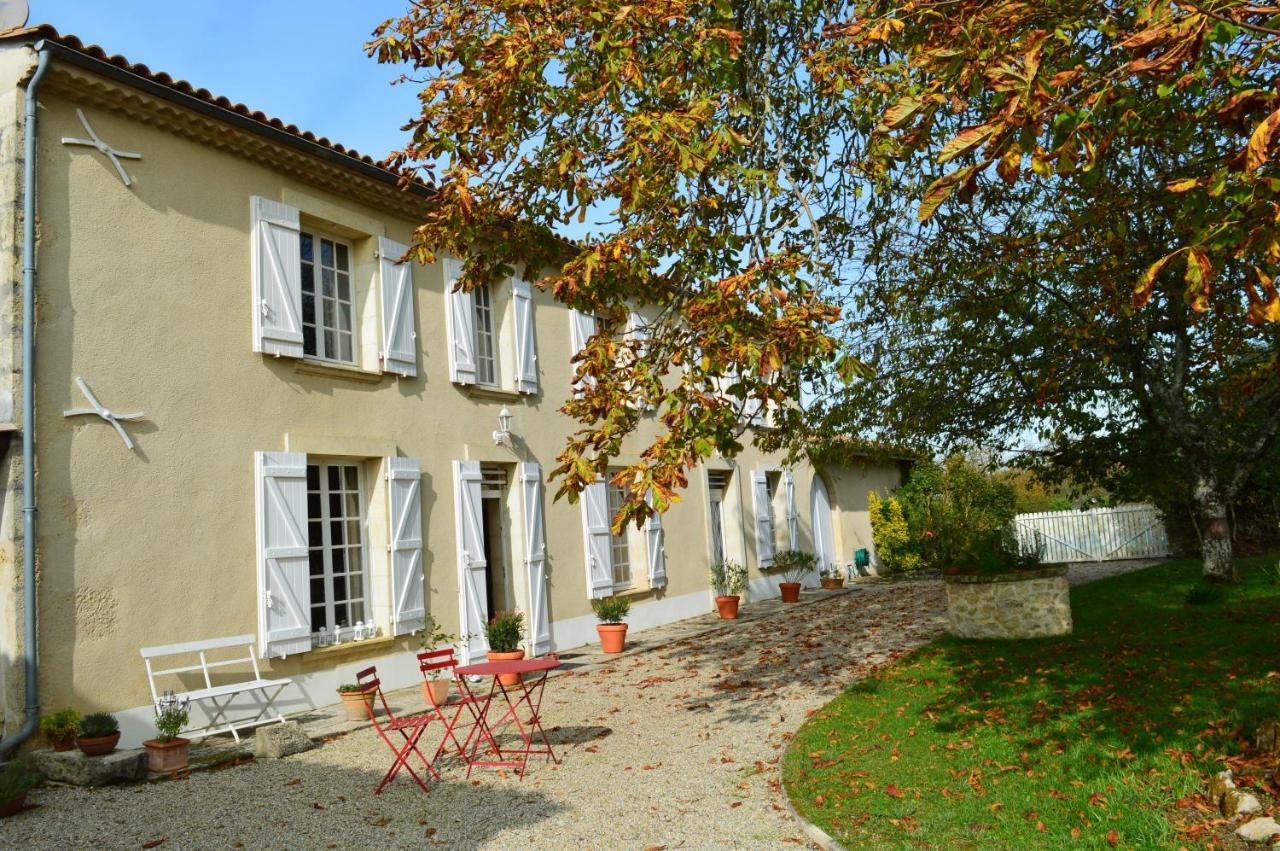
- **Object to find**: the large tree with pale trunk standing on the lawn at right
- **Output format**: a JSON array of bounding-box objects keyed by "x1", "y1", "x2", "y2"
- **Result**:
[{"x1": 823, "y1": 0, "x2": 1280, "y2": 578}]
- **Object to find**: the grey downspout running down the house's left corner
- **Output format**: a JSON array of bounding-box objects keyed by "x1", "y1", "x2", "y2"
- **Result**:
[{"x1": 0, "y1": 41, "x2": 49, "y2": 755}]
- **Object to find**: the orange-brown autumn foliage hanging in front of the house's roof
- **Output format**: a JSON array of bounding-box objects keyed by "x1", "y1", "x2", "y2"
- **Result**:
[{"x1": 370, "y1": 0, "x2": 859, "y2": 523}]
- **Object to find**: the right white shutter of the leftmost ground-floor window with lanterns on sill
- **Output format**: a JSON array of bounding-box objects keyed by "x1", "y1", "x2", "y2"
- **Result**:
[{"x1": 387, "y1": 457, "x2": 426, "y2": 635}]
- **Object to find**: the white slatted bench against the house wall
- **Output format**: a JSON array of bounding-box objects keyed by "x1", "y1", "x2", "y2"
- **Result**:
[{"x1": 142, "y1": 635, "x2": 293, "y2": 741}]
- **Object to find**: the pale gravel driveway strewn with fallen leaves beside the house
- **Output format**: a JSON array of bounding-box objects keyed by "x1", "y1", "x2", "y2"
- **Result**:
[{"x1": 0, "y1": 560, "x2": 1152, "y2": 848}]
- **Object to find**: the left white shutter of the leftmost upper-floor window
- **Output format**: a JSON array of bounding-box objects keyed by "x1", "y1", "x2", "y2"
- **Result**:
[{"x1": 250, "y1": 196, "x2": 302, "y2": 357}]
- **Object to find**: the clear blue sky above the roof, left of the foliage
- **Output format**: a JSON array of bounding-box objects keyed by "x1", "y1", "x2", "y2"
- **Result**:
[{"x1": 29, "y1": 0, "x2": 416, "y2": 159}]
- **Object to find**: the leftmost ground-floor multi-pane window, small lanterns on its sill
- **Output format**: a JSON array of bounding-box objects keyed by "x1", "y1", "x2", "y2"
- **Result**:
[{"x1": 307, "y1": 461, "x2": 369, "y2": 633}]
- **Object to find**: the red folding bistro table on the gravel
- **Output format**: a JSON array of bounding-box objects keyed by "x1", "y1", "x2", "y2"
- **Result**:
[{"x1": 453, "y1": 656, "x2": 559, "y2": 779}]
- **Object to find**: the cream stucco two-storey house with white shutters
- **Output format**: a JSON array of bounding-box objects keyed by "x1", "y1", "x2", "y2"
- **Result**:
[{"x1": 0, "y1": 27, "x2": 900, "y2": 742}]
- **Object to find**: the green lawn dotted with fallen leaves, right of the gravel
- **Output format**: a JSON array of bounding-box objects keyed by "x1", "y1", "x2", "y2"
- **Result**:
[{"x1": 783, "y1": 555, "x2": 1280, "y2": 848}]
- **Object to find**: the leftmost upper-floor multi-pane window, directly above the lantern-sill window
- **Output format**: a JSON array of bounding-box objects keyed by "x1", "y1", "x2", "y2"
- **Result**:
[{"x1": 300, "y1": 230, "x2": 356, "y2": 363}]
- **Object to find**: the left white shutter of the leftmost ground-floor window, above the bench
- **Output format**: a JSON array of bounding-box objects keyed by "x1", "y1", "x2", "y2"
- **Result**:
[{"x1": 253, "y1": 452, "x2": 311, "y2": 658}]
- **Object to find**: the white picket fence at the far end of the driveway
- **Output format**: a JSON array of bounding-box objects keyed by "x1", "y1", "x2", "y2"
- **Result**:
[{"x1": 1014, "y1": 505, "x2": 1170, "y2": 563}]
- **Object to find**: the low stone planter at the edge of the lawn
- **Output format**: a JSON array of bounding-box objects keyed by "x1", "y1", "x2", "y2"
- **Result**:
[{"x1": 943, "y1": 567, "x2": 1071, "y2": 639}]
